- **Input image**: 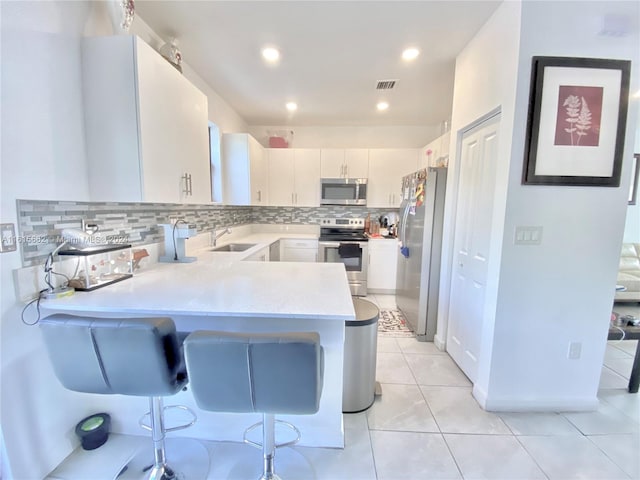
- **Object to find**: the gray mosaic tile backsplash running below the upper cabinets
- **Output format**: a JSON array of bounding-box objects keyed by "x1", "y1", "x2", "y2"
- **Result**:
[{"x1": 17, "y1": 200, "x2": 389, "y2": 267}]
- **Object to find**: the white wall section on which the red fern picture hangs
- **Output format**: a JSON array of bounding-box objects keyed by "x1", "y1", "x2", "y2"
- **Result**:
[{"x1": 474, "y1": 1, "x2": 640, "y2": 410}]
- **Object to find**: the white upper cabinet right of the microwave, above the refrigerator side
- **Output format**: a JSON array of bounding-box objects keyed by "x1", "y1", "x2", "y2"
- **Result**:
[{"x1": 367, "y1": 148, "x2": 420, "y2": 208}]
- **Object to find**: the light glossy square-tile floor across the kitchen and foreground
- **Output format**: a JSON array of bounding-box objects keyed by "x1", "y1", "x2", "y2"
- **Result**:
[{"x1": 46, "y1": 295, "x2": 640, "y2": 480}]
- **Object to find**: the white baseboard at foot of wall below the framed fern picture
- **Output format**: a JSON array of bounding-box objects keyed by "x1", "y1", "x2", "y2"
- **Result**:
[{"x1": 473, "y1": 385, "x2": 600, "y2": 412}]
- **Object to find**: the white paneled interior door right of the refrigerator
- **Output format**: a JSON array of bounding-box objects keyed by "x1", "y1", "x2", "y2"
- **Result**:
[{"x1": 447, "y1": 115, "x2": 500, "y2": 382}]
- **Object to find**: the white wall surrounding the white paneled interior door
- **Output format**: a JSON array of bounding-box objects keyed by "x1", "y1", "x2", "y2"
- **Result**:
[{"x1": 434, "y1": 2, "x2": 520, "y2": 362}]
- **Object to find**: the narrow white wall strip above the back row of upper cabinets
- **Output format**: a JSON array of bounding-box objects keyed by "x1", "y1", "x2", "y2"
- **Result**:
[{"x1": 249, "y1": 125, "x2": 440, "y2": 148}]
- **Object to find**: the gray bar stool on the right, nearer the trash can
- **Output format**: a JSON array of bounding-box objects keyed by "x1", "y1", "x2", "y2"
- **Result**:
[{"x1": 184, "y1": 331, "x2": 324, "y2": 480}]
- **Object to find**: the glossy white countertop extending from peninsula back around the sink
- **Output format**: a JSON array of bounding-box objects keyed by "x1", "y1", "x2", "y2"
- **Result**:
[{"x1": 41, "y1": 233, "x2": 355, "y2": 321}]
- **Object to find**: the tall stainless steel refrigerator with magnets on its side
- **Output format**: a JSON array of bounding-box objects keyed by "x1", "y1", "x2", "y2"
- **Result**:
[{"x1": 396, "y1": 167, "x2": 447, "y2": 342}]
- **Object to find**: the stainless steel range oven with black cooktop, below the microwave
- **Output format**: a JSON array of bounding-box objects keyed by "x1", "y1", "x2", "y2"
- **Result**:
[{"x1": 318, "y1": 218, "x2": 369, "y2": 296}]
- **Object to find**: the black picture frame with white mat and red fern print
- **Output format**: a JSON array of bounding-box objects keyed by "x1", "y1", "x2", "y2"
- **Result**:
[{"x1": 522, "y1": 56, "x2": 631, "y2": 187}]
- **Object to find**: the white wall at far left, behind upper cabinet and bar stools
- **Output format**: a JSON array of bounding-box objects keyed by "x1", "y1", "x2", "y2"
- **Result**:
[{"x1": 0, "y1": 0, "x2": 246, "y2": 479}]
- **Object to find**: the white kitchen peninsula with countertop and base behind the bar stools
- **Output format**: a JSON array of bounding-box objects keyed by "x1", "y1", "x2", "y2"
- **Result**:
[{"x1": 42, "y1": 248, "x2": 355, "y2": 448}]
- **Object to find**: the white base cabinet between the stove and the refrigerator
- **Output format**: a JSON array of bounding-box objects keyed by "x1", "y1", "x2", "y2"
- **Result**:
[{"x1": 367, "y1": 238, "x2": 400, "y2": 293}]
